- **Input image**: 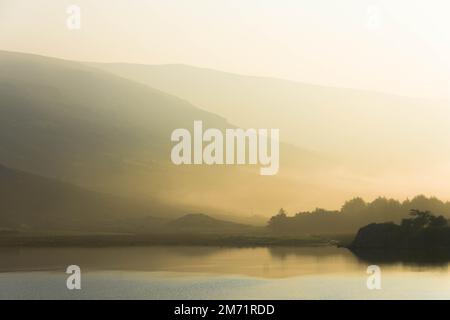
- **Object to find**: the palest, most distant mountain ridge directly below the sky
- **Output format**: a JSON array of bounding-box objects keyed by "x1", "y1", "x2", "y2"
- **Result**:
[{"x1": 90, "y1": 63, "x2": 450, "y2": 175}]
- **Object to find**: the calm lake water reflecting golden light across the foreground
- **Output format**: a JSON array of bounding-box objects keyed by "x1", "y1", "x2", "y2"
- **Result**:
[{"x1": 0, "y1": 246, "x2": 450, "y2": 299}]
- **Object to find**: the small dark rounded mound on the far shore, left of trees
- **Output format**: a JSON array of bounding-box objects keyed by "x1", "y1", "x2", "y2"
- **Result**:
[{"x1": 164, "y1": 213, "x2": 253, "y2": 233}]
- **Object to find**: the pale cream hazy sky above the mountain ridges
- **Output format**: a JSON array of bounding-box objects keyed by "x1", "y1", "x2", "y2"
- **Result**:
[{"x1": 0, "y1": 0, "x2": 450, "y2": 99}]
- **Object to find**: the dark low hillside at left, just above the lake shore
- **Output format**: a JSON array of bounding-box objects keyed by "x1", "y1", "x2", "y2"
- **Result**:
[{"x1": 0, "y1": 165, "x2": 167, "y2": 232}]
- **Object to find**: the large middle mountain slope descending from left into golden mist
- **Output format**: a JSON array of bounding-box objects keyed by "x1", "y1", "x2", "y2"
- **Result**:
[{"x1": 0, "y1": 52, "x2": 334, "y2": 216}]
